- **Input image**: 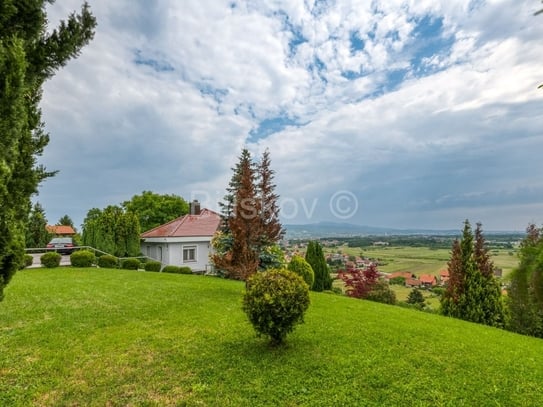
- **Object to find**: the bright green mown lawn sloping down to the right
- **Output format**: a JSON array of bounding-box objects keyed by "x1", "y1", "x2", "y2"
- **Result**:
[{"x1": 0, "y1": 268, "x2": 543, "y2": 406}]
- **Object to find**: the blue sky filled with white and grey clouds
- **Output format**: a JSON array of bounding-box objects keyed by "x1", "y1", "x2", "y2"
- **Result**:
[{"x1": 39, "y1": 0, "x2": 543, "y2": 230}]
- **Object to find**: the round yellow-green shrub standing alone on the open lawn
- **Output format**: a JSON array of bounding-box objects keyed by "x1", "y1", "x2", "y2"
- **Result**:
[{"x1": 243, "y1": 269, "x2": 309, "y2": 345}]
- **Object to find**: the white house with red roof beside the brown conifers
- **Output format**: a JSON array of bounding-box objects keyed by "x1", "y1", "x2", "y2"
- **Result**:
[{"x1": 141, "y1": 201, "x2": 221, "y2": 272}]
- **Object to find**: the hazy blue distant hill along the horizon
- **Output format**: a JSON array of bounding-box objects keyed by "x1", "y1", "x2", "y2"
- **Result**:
[{"x1": 284, "y1": 222, "x2": 522, "y2": 239}]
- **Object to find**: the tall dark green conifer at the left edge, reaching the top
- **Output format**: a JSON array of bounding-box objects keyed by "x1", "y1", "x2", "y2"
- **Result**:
[{"x1": 0, "y1": 0, "x2": 96, "y2": 300}]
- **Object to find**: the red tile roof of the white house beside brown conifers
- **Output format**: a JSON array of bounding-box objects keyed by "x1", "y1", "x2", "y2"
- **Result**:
[{"x1": 141, "y1": 208, "x2": 221, "y2": 238}]
